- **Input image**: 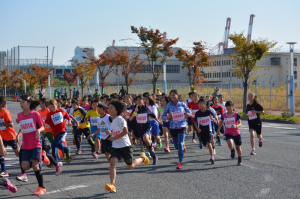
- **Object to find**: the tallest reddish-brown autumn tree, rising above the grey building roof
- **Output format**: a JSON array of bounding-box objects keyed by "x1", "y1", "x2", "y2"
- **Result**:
[{"x1": 131, "y1": 26, "x2": 179, "y2": 93}]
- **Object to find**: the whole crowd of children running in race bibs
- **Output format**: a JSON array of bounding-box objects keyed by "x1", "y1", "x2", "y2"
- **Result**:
[{"x1": 0, "y1": 90, "x2": 264, "y2": 195}]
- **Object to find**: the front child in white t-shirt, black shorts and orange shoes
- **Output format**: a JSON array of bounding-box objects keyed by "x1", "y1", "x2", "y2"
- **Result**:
[{"x1": 105, "y1": 100, "x2": 149, "y2": 192}]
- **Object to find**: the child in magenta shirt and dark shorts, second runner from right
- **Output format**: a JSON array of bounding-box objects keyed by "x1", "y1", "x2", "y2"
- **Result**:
[{"x1": 217, "y1": 101, "x2": 242, "y2": 166}]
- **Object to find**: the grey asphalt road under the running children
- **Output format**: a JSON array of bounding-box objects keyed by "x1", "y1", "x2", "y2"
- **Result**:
[{"x1": 0, "y1": 102, "x2": 300, "y2": 199}]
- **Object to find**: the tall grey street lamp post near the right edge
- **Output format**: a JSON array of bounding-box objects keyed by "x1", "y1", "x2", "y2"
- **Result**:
[{"x1": 287, "y1": 42, "x2": 297, "y2": 116}]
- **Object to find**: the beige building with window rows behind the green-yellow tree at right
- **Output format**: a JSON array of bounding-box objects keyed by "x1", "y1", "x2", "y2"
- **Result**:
[{"x1": 203, "y1": 49, "x2": 300, "y2": 87}]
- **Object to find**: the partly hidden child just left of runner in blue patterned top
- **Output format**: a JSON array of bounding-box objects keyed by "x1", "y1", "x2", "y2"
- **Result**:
[{"x1": 158, "y1": 96, "x2": 171, "y2": 153}]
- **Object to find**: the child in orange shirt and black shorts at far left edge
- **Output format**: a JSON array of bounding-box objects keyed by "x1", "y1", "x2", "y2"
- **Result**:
[{"x1": 0, "y1": 96, "x2": 20, "y2": 177}]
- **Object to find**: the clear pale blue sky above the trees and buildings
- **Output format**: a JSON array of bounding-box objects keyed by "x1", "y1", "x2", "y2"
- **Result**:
[{"x1": 0, "y1": 0, "x2": 300, "y2": 64}]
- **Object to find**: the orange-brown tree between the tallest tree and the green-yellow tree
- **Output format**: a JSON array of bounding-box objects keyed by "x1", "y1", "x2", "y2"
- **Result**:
[{"x1": 175, "y1": 42, "x2": 211, "y2": 86}]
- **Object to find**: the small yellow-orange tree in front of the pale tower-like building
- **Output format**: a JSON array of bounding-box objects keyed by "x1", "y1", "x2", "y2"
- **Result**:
[{"x1": 73, "y1": 60, "x2": 96, "y2": 97}]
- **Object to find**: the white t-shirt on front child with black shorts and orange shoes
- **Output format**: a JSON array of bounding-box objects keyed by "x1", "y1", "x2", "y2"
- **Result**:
[{"x1": 111, "y1": 116, "x2": 131, "y2": 148}]
